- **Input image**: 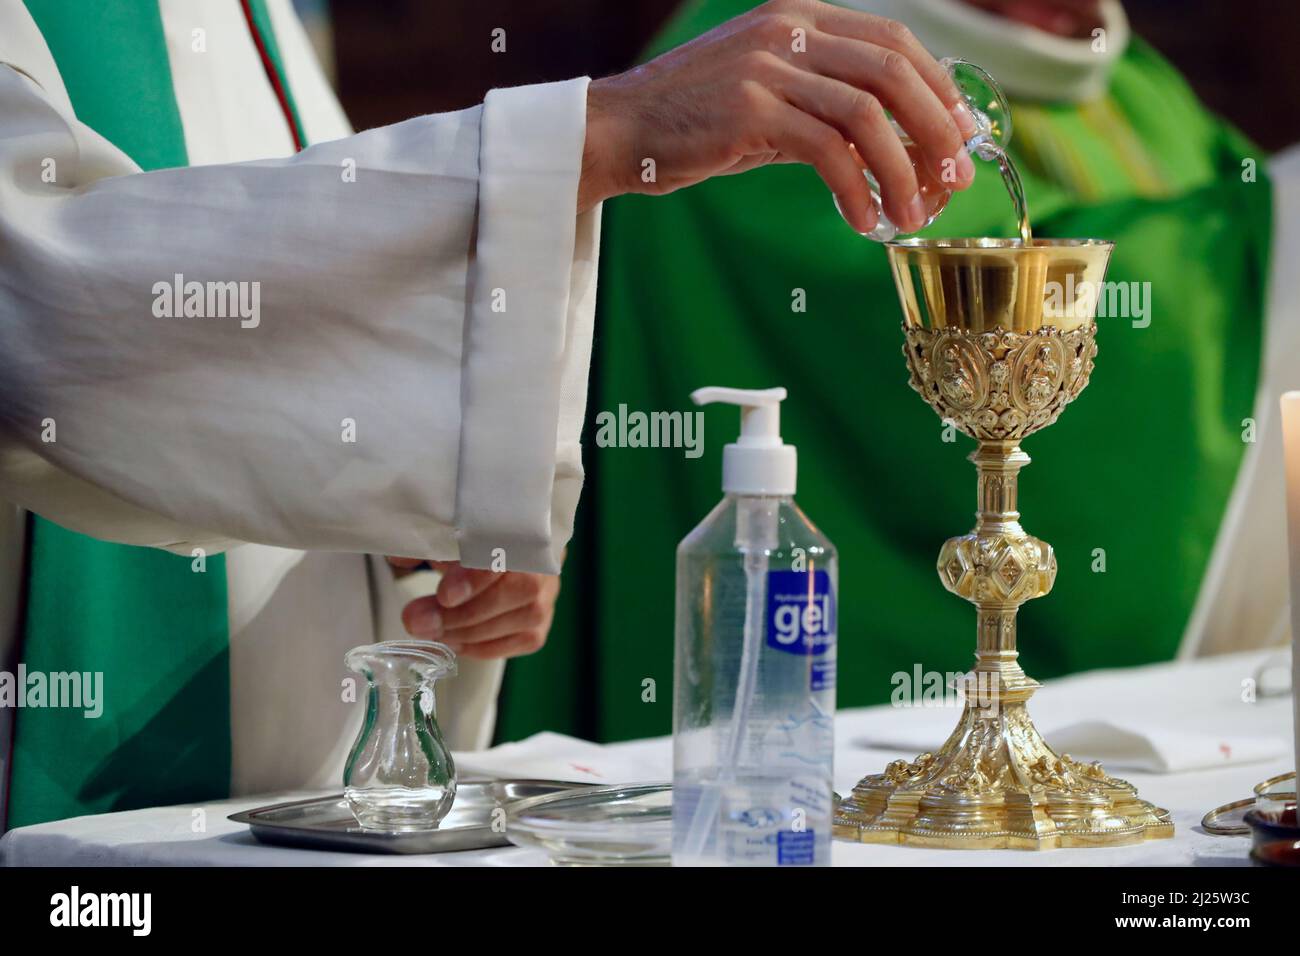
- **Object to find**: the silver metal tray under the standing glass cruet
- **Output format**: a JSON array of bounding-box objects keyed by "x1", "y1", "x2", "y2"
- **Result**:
[{"x1": 228, "y1": 780, "x2": 590, "y2": 853}]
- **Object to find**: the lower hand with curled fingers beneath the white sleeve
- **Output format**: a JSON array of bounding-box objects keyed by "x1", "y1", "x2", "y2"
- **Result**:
[{"x1": 389, "y1": 558, "x2": 560, "y2": 658}]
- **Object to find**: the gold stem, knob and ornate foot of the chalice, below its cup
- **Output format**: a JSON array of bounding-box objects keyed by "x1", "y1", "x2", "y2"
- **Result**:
[{"x1": 835, "y1": 426, "x2": 1173, "y2": 849}]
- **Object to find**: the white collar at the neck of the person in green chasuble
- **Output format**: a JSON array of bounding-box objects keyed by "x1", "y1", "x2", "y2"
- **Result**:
[{"x1": 835, "y1": 0, "x2": 1130, "y2": 103}]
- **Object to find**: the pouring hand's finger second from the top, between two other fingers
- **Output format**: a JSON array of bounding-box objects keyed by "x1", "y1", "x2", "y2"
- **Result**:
[{"x1": 792, "y1": 34, "x2": 975, "y2": 187}]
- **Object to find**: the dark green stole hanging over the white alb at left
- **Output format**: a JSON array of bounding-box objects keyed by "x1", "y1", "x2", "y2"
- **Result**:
[{"x1": 7, "y1": 0, "x2": 296, "y2": 827}]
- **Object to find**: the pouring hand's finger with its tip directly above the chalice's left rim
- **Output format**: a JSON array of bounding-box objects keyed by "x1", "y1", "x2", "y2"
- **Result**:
[{"x1": 779, "y1": 66, "x2": 927, "y2": 233}]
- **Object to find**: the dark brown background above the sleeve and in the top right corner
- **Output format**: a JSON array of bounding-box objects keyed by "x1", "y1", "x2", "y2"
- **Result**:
[{"x1": 330, "y1": 0, "x2": 1300, "y2": 150}]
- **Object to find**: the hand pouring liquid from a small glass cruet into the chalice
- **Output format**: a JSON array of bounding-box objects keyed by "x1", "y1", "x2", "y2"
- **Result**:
[{"x1": 579, "y1": 0, "x2": 975, "y2": 233}]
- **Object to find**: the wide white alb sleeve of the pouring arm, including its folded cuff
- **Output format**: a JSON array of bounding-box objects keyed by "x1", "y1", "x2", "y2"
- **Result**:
[{"x1": 0, "y1": 66, "x2": 599, "y2": 571}]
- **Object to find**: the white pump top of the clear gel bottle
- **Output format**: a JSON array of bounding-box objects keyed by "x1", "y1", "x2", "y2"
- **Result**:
[{"x1": 690, "y1": 386, "x2": 798, "y2": 497}]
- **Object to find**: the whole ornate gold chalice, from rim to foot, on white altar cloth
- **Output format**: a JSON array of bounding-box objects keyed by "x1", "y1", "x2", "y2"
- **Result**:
[{"x1": 835, "y1": 239, "x2": 1174, "y2": 849}]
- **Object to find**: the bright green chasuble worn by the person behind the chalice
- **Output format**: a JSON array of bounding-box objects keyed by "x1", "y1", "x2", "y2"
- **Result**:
[{"x1": 503, "y1": 0, "x2": 1271, "y2": 740}]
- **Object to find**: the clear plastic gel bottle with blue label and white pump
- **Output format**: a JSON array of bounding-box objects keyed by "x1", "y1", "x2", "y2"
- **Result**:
[{"x1": 672, "y1": 388, "x2": 839, "y2": 866}]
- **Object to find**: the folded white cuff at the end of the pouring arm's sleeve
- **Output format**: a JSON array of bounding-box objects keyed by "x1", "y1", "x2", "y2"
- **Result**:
[{"x1": 456, "y1": 77, "x2": 601, "y2": 574}]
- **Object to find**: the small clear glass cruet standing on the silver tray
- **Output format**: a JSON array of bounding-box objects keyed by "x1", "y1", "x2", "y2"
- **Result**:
[{"x1": 343, "y1": 641, "x2": 456, "y2": 830}]
